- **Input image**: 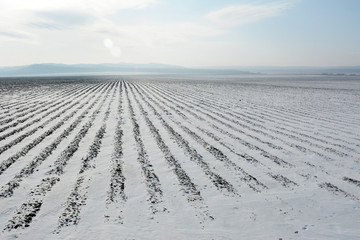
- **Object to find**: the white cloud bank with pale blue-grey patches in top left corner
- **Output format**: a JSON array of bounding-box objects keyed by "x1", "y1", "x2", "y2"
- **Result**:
[{"x1": 0, "y1": 0, "x2": 157, "y2": 41}]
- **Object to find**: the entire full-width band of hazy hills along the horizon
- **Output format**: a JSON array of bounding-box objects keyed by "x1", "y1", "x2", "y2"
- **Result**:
[{"x1": 0, "y1": 63, "x2": 360, "y2": 77}]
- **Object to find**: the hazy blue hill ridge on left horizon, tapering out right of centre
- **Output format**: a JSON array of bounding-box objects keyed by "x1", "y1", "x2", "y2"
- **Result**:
[{"x1": 0, "y1": 63, "x2": 252, "y2": 77}]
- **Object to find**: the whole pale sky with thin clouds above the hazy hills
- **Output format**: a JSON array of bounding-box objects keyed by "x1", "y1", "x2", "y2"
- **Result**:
[{"x1": 0, "y1": 0, "x2": 360, "y2": 67}]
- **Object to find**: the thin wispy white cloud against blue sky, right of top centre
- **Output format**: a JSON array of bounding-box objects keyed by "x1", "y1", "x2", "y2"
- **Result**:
[{"x1": 206, "y1": 1, "x2": 293, "y2": 25}]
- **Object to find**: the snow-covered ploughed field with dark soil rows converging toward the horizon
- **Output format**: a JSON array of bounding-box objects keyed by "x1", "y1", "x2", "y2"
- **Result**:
[{"x1": 0, "y1": 75, "x2": 360, "y2": 239}]
